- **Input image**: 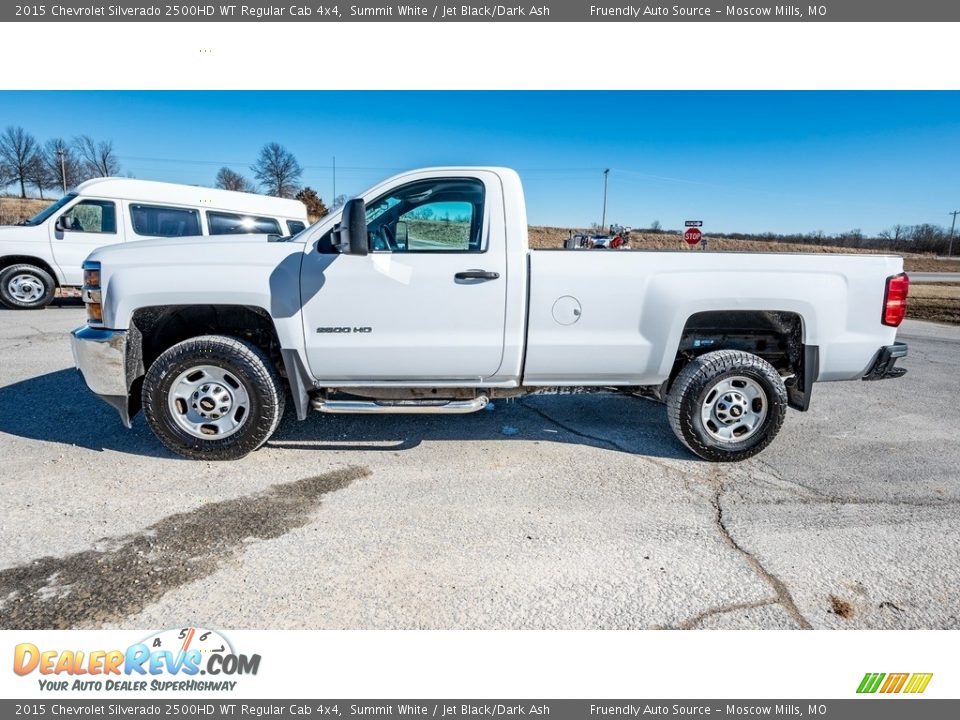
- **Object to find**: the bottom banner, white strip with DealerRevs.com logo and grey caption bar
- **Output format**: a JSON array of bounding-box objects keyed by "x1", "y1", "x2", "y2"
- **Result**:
[{"x1": 0, "y1": 624, "x2": 960, "y2": 704}]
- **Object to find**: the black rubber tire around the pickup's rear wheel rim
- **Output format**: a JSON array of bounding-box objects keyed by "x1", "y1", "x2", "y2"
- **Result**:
[{"x1": 667, "y1": 350, "x2": 787, "y2": 462}]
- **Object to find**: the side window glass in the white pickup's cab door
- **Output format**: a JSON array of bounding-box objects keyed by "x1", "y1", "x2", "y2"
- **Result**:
[{"x1": 367, "y1": 178, "x2": 484, "y2": 253}]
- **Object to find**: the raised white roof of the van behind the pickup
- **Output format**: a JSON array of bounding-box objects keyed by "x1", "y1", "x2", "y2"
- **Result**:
[{"x1": 76, "y1": 177, "x2": 307, "y2": 220}]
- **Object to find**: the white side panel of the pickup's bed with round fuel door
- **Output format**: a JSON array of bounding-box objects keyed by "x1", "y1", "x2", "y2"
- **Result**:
[{"x1": 524, "y1": 250, "x2": 903, "y2": 385}]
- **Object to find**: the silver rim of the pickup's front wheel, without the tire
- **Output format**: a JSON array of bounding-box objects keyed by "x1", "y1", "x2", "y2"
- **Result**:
[{"x1": 167, "y1": 365, "x2": 250, "y2": 440}]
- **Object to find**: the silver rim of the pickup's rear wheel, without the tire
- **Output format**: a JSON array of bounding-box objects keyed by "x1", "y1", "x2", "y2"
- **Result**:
[{"x1": 700, "y1": 375, "x2": 768, "y2": 443}]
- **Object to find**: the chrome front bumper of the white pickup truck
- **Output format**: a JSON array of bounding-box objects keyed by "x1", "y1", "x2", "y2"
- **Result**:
[{"x1": 70, "y1": 327, "x2": 130, "y2": 427}]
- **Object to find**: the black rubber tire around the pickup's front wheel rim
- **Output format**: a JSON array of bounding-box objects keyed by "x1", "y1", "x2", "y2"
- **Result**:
[{"x1": 143, "y1": 335, "x2": 286, "y2": 460}]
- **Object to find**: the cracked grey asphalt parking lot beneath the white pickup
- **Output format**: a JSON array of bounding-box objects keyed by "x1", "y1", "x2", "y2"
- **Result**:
[{"x1": 0, "y1": 304, "x2": 960, "y2": 629}]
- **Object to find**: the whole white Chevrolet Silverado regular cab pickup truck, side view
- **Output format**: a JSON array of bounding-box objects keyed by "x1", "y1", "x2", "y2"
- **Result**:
[{"x1": 72, "y1": 167, "x2": 909, "y2": 461}]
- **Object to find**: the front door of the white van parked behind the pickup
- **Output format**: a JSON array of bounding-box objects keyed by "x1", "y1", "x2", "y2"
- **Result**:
[{"x1": 47, "y1": 198, "x2": 123, "y2": 285}]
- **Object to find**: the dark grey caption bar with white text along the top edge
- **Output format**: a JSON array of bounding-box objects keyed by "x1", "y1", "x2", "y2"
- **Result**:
[{"x1": 0, "y1": 0, "x2": 960, "y2": 23}]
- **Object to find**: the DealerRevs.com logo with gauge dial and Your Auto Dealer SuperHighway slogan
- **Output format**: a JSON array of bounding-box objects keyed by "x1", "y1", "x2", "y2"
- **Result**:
[{"x1": 13, "y1": 627, "x2": 260, "y2": 692}]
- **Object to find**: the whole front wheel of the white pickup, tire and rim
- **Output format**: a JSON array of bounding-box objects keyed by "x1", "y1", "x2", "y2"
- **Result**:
[{"x1": 143, "y1": 335, "x2": 285, "y2": 460}]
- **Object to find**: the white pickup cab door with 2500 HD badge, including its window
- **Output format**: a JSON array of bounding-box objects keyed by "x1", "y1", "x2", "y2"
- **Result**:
[{"x1": 301, "y1": 171, "x2": 507, "y2": 383}]
